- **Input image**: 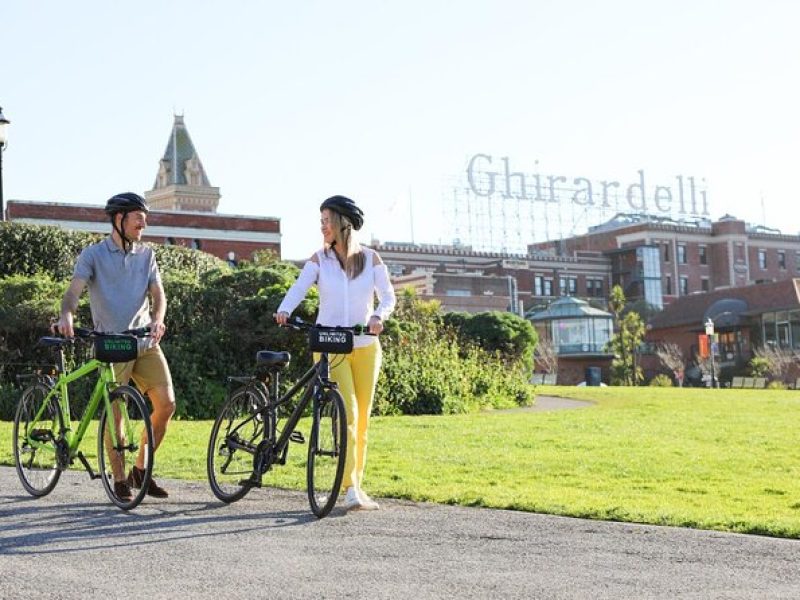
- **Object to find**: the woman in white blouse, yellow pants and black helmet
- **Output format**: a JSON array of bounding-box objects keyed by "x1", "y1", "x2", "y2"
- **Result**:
[{"x1": 275, "y1": 196, "x2": 395, "y2": 510}]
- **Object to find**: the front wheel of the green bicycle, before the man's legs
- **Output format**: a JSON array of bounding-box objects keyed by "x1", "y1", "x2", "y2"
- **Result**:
[{"x1": 97, "y1": 385, "x2": 155, "y2": 510}]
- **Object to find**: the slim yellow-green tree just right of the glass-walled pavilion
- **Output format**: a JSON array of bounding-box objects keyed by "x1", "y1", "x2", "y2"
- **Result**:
[{"x1": 608, "y1": 285, "x2": 645, "y2": 385}]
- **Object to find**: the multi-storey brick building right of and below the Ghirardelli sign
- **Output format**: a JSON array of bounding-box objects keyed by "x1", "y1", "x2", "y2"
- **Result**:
[{"x1": 529, "y1": 215, "x2": 800, "y2": 307}]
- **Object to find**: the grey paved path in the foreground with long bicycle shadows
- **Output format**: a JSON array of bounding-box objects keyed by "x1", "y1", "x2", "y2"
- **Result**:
[{"x1": 0, "y1": 467, "x2": 800, "y2": 599}]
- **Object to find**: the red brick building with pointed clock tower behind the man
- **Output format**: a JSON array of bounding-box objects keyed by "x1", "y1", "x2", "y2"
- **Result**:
[{"x1": 6, "y1": 115, "x2": 281, "y2": 261}]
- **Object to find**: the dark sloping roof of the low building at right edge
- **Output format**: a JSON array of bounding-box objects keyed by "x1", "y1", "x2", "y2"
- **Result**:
[{"x1": 649, "y1": 278, "x2": 800, "y2": 329}]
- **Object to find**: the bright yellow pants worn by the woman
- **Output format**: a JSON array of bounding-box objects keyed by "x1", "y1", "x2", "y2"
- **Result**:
[{"x1": 314, "y1": 340, "x2": 383, "y2": 489}]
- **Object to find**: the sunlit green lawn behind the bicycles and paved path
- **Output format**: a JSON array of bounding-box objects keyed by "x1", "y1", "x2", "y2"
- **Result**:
[{"x1": 0, "y1": 387, "x2": 800, "y2": 538}]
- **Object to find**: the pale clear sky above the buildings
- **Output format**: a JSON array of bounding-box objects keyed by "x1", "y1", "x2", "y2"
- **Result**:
[{"x1": 0, "y1": 0, "x2": 800, "y2": 258}]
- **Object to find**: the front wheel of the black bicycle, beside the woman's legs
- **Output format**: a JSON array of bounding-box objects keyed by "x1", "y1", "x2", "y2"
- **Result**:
[{"x1": 306, "y1": 390, "x2": 347, "y2": 518}]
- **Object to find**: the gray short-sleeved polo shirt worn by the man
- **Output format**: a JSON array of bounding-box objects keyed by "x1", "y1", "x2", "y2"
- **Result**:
[{"x1": 74, "y1": 237, "x2": 161, "y2": 346}]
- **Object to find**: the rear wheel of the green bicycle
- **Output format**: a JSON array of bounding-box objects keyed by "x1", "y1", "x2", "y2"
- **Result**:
[{"x1": 13, "y1": 383, "x2": 65, "y2": 497}]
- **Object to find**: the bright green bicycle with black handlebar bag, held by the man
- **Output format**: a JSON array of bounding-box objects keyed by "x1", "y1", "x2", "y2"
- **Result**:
[{"x1": 13, "y1": 328, "x2": 153, "y2": 510}]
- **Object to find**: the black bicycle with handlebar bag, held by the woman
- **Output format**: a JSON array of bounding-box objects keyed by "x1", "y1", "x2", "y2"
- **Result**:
[{"x1": 207, "y1": 318, "x2": 367, "y2": 518}]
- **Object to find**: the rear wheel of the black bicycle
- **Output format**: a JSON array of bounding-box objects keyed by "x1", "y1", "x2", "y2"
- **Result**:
[{"x1": 206, "y1": 387, "x2": 271, "y2": 502}]
